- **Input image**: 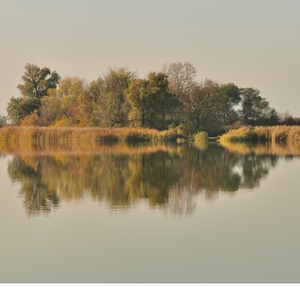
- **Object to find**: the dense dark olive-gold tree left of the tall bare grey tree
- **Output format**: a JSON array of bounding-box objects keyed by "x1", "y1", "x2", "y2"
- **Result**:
[{"x1": 125, "y1": 72, "x2": 174, "y2": 129}]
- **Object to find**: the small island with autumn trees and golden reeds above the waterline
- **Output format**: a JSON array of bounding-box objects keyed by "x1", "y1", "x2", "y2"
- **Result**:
[{"x1": 0, "y1": 62, "x2": 300, "y2": 143}]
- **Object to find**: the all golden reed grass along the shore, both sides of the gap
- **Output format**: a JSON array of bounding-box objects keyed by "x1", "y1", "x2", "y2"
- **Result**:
[{"x1": 0, "y1": 126, "x2": 300, "y2": 145}]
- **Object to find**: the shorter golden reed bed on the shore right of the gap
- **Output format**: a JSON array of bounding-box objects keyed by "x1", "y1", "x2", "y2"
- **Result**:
[{"x1": 219, "y1": 126, "x2": 300, "y2": 143}]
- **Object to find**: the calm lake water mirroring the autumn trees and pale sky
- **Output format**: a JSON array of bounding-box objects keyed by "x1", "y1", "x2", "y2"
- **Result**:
[{"x1": 0, "y1": 144, "x2": 300, "y2": 283}]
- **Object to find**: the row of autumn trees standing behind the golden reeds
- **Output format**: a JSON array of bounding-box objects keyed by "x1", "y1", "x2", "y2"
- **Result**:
[{"x1": 4, "y1": 62, "x2": 298, "y2": 136}]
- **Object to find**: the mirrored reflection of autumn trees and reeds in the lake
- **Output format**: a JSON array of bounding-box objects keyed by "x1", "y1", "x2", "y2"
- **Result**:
[{"x1": 0, "y1": 144, "x2": 298, "y2": 216}]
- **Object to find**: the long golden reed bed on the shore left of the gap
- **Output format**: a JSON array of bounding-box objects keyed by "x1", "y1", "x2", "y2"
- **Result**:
[{"x1": 0, "y1": 126, "x2": 183, "y2": 143}]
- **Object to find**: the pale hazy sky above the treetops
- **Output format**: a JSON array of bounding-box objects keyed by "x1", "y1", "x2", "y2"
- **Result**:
[{"x1": 0, "y1": 0, "x2": 300, "y2": 117}]
